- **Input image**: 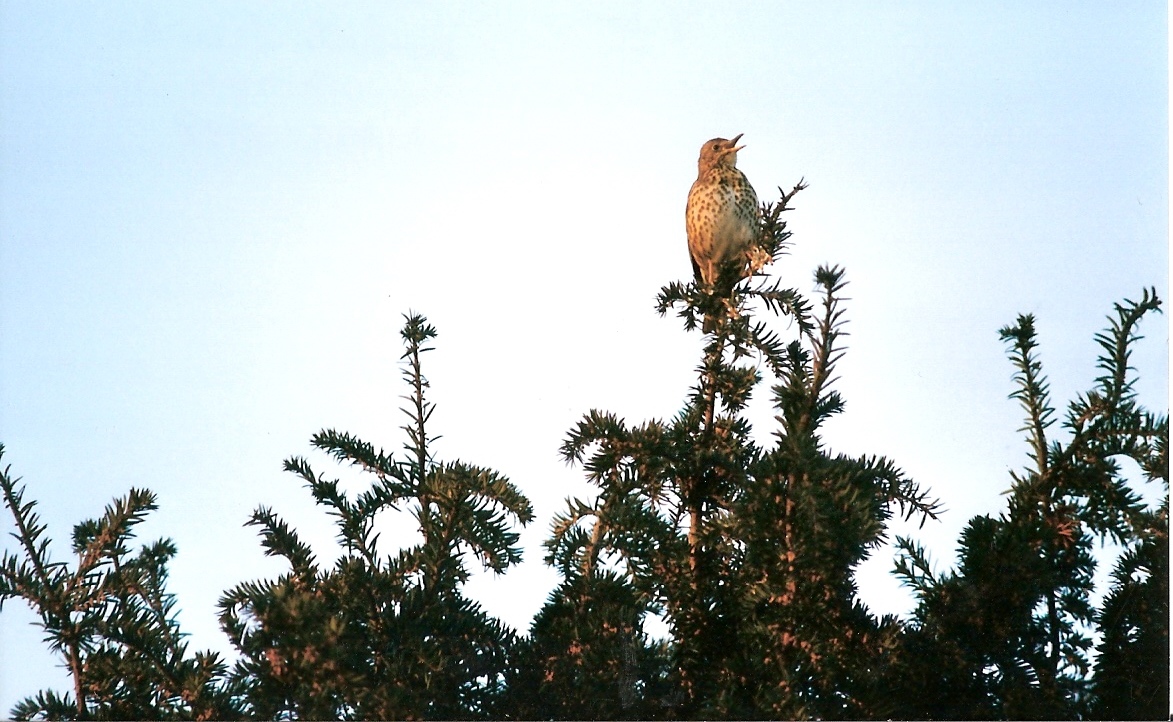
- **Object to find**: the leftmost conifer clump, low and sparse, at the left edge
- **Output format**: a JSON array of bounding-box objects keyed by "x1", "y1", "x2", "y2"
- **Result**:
[{"x1": 0, "y1": 444, "x2": 239, "y2": 720}]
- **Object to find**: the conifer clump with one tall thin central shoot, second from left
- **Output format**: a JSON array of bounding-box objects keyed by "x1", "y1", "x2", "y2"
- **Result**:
[{"x1": 221, "y1": 315, "x2": 533, "y2": 720}]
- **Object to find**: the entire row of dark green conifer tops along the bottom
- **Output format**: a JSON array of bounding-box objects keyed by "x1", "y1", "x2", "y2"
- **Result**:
[{"x1": 0, "y1": 183, "x2": 1169, "y2": 720}]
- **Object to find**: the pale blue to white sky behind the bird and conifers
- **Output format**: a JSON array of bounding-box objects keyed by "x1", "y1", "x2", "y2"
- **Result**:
[{"x1": 0, "y1": 1, "x2": 1169, "y2": 714}]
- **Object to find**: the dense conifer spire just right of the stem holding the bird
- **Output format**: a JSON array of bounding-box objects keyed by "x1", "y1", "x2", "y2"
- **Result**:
[{"x1": 727, "y1": 267, "x2": 938, "y2": 718}]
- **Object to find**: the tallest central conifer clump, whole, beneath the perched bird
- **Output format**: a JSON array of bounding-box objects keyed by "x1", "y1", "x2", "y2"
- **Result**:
[{"x1": 534, "y1": 183, "x2": 936, "y2": 717}]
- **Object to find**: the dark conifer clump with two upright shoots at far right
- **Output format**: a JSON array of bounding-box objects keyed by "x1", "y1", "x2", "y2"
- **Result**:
[{"x1": 891, "y1": 291, "x2": 1168, "y2": 718}]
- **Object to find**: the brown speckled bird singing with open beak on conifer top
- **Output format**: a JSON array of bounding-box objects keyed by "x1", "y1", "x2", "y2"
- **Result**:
[{"x1": 684, "y1": 134, "x2": 761, "y2": 331}]
